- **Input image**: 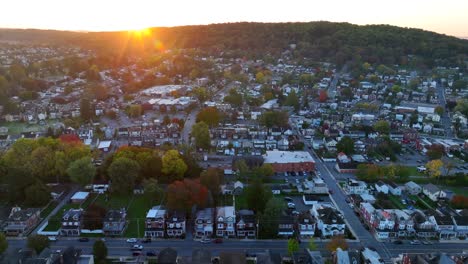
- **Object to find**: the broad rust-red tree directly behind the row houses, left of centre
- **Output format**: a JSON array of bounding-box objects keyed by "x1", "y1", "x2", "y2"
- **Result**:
[{"x1": 166, "y1": 179, "x2": 208, "y2": 213}]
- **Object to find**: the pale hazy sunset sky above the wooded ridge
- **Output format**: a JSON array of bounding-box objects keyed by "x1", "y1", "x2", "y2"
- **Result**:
[{"x1": 0, "y1": 0, "x2": 468, "y2": 37}]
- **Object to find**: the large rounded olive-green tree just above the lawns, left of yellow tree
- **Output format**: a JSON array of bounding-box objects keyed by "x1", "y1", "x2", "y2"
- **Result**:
[{"x1": 107, "y1": 158, "x2": 140, "y2": 194}]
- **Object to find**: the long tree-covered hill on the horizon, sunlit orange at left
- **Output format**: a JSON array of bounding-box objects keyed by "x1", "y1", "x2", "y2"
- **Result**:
[{"x1": 0, "y1": 22, "x2": 468, "y2": 67}]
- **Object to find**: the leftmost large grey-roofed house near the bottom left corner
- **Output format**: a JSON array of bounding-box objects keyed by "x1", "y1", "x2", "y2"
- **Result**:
[{"x1": 4, "y1": 207, "x2": 41, "y2": 236}]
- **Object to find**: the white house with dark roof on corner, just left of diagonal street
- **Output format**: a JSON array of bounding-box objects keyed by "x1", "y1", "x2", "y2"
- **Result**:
[{"x1": 312, "y1": 205, "x2": 346, "y2": 237}]
